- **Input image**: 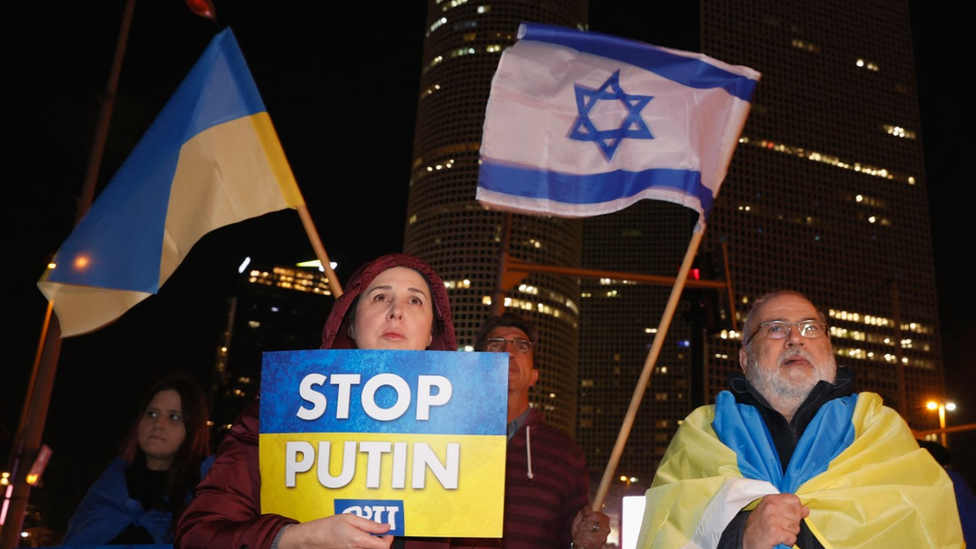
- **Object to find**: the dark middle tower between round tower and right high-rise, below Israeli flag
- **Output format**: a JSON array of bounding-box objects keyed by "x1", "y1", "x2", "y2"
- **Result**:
[{"x1": 576, "y1": 200, "x2": 701, "y2": 482}]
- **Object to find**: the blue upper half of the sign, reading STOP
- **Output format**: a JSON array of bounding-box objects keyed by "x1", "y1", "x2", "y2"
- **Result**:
[{"x1": 261, "y1": 349, "x2": 508, "y2": 435}]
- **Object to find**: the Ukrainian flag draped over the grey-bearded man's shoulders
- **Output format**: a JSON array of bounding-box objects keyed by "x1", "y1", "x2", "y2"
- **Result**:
[{"x1": 638, "y1": 393, "x2": 964, "y2": 549}]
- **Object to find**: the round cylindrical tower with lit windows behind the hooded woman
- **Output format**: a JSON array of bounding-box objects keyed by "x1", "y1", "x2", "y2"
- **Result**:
[{"x1": 404, "y1": 0, "x2": 587, "y2": 434}]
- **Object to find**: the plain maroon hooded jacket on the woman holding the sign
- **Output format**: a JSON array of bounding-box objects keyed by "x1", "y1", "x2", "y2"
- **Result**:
[{"x1": 176, "y1": 254, "x2": 457, "y2": 549}]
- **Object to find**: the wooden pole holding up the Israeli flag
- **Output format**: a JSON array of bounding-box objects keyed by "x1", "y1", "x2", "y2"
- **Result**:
[{"x1": 592, "y1": 223, "x2": 705, "y2": 511}]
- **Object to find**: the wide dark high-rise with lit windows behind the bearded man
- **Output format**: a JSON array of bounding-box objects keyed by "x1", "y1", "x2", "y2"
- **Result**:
[{"x1": 702, "y1": 0, "x2": 944, "y2": 428}]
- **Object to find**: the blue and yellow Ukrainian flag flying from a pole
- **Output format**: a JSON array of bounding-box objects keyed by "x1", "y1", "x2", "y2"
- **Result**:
[{"x1": 38, "y1": 29, "x2": 304, "y2": 336}]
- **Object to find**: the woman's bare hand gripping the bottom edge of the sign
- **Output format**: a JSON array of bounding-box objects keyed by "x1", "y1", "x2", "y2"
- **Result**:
[{"x1": 278, "y1": 514, "x2": 393, "y2": 549}]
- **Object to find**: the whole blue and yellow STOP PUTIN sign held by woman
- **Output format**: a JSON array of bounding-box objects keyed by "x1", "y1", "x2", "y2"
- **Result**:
[{"x1": 259, "y1": 350, "x2": 508, "y2": 538}]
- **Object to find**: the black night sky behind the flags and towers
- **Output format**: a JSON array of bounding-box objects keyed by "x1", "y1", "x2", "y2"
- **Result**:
[{"x1": 0, "y1": 0, "x2": 976, "y2": 532}]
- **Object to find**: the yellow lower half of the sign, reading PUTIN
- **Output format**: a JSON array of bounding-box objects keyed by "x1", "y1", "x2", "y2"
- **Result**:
[{"x1": 260, "y1": 433, "x2": 507, "y2": 538}]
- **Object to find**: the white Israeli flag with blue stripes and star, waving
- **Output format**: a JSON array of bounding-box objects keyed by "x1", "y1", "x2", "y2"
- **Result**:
[{"x1": 477, "y1": 24, "x2": 760, "y2": 218}]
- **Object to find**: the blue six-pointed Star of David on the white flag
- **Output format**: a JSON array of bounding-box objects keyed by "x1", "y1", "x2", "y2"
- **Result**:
[{"x1": 569, "y1": 70, "x2": 654, "y2": 162}]
